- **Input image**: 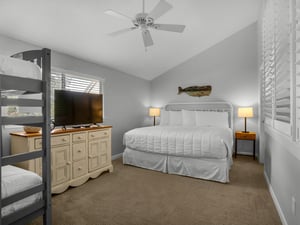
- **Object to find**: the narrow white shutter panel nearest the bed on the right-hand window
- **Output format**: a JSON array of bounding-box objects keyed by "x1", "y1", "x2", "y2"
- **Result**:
[{"x1": 262, "y1": 1, "x2": 275, "y2": 124}]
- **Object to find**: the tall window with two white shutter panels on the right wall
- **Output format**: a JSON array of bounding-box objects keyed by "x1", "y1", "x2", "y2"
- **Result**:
[{"x1": 262, "y1": 0, "x2": 292, "y2": 136}]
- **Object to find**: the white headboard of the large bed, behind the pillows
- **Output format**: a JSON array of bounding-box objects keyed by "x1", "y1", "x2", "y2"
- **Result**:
[{"x1": 165, "y1": 101, "x2": 233, "y2": 129}]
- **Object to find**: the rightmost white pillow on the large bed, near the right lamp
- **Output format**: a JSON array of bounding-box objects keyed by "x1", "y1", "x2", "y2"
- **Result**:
[{"x1": 196, "y1": 111, "x2": 229, "y2": 128}]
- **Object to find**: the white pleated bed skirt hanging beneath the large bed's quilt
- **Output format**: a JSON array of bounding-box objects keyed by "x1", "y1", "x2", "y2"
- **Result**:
[{"x1": 123, "y1": 148, "x2": 232, "y2": 183}]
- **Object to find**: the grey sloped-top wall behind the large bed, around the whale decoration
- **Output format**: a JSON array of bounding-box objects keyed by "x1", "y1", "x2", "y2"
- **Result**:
[{"x1": 151, "y1": 23, "x2": 259, "y2": 154}]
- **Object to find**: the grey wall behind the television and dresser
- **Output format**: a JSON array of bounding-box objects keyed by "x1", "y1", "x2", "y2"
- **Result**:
[{"x1": 0, "y1": 35, "x2": 150, "y2": 155}]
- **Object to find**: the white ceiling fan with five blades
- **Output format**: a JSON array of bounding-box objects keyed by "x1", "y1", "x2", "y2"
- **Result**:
[{"x1": 105, "y1": 0, "x2": 185, "y2": 48}]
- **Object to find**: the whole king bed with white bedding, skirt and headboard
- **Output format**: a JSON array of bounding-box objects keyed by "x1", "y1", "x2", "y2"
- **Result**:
[{"x1": 123, "y1": 101, "x2": 233, "y2": 183}]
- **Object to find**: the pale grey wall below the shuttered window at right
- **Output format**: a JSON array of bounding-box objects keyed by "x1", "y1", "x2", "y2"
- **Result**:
[{"x1": 264, "y1": 128, "x2": 300, "y2": 225}]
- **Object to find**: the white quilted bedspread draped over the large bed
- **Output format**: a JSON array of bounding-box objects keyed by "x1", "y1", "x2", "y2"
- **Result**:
[{"x1": 123, "y1": 126, "x2": 233, "y2": 159}]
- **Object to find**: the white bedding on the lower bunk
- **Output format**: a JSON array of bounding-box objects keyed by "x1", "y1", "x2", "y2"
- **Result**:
[{"x1": 1, "y1": 166, "x2": 42, "y2": 217}]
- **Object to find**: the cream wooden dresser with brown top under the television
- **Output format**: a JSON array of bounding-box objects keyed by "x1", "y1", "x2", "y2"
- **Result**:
[{"x1": 10, "y1": 126, "x2": 113, "y2": 194}]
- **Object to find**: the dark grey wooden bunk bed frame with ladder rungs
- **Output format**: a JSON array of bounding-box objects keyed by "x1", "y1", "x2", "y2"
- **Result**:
[{"x1": 0, "y1": 49, "x2": 51, "y2": 225}]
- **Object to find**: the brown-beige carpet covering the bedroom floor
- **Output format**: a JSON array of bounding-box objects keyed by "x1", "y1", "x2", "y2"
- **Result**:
[{"x1": 32, "y1": 156, "x2": 281, "y2": 225}]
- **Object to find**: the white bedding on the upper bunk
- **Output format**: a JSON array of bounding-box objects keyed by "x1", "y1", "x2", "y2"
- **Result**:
[{"x1": 0, "y1": 55, "x2": 42, "y2": 80}]
